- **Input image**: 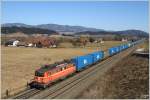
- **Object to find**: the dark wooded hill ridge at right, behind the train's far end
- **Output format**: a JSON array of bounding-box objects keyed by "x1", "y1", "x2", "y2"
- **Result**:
[{"x1": 75, "y1": 30, "x2": 149, "y2": 37}]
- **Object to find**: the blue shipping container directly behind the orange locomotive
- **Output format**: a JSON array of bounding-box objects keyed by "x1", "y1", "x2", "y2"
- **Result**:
[{"x1": 72, "y1": 55, "x2": 93, "y2": 71}]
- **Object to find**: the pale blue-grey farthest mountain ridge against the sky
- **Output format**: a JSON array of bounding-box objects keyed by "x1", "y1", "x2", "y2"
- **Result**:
[{"x1": 2, "y1": 23, "x2": 103, "y2": 33}]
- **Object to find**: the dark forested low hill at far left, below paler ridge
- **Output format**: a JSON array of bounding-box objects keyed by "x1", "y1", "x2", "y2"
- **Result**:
[{"x1": 1, "y1": 26, "x2": 59, "y2": 35}]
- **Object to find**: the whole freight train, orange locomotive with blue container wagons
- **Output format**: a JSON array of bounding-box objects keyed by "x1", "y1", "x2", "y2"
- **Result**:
[{"x1": 29, "y1": 40, "x2": 143, "y2": 88}]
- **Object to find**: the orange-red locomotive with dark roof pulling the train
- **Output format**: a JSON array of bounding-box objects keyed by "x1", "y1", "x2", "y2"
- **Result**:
[{"x1": 29, "y1": 62, "x2": 76, "y2": 88}]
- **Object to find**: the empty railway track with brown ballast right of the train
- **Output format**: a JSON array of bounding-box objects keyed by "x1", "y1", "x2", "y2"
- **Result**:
[{"x1": 8, "y1": 44, "x2": 137, "y2": 99}]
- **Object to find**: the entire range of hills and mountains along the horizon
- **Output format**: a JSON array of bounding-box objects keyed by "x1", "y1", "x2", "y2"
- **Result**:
[{"x1": 1, "y1": 23, "x2": 149, "y2": 37}]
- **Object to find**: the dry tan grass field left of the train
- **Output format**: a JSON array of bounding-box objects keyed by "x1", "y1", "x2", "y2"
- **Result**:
[{"x1": 1, "y1": 41, "x2": 126, "y2": 96}]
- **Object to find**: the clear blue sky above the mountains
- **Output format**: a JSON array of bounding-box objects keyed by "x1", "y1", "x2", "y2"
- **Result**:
[{"x1": 1, "y1": 1, "x2": 148, "y2": 32}]
